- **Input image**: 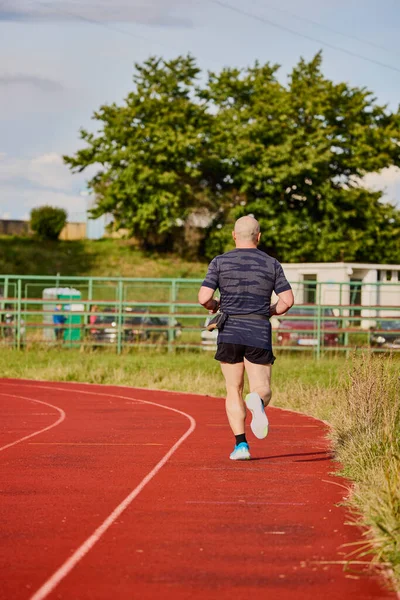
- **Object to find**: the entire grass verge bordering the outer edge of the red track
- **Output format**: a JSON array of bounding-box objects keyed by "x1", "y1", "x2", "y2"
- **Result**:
[{"x1": 0, "y1": 348, "x2": 400, "y2": 589}]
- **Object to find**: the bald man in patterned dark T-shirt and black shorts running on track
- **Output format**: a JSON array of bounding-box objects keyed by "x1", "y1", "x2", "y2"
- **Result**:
[{"x1": 199, "y1": 216, "x2": 294, "y2": 460}]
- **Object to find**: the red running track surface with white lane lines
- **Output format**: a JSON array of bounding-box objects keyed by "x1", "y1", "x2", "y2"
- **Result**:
[{"x1": 0, "y1": 379, "x2": 396, "y2": 600}]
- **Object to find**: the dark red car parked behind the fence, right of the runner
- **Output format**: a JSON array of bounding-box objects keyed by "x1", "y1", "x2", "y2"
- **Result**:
[{"x1": 277, "y1": 306, "x2": 340, "y2": 346}]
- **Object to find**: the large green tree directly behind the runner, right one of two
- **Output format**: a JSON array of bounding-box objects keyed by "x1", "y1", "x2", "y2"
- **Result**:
[{"x1": 207, "y1": 54, "x2": 400, "y2": 262}]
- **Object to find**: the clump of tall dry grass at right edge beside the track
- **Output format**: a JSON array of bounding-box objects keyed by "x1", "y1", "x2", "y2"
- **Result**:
[{"x1": 332, "y1": 354, "x2": 400, "y2": 588}]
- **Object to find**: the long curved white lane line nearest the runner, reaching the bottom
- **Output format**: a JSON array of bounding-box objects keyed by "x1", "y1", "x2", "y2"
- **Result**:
[{"x1": 5, "y1": 384, "x2": 196, "y2": 600}]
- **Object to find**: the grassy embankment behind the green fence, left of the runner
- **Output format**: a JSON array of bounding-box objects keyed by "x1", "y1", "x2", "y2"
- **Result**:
[{"x1": 0, "y1": 236, "x2": 211, "y2": 350}]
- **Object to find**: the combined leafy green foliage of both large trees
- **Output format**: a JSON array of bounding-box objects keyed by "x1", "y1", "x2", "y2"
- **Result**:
[{"x1": 65, "y1": 54, "x2": 400, "y2": 262}]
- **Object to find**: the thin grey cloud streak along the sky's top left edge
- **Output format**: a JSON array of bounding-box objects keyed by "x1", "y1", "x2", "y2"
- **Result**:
[{"x1": 0, "y1": 0, "x2": 192, "y2": 27}]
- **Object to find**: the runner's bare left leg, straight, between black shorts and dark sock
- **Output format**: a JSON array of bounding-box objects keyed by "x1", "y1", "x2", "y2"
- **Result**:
[{"x1": 221, "y1": 362, "x2": 246, "y2": 435}]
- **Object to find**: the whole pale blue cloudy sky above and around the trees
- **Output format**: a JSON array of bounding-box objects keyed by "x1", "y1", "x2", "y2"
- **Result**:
[{"x1": 0, "y1": 0, "x2": 400, "y2": 220}]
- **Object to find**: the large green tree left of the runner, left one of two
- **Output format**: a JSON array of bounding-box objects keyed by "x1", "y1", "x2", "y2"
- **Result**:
[{"x1": 65, "y1": 57, "x2": 219, "y2": 248}]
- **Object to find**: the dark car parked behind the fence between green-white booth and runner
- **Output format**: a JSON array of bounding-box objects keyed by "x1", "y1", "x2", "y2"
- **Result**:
[{"x1": 90, "y1": 307, "x2": 182, "y2": 344}]
